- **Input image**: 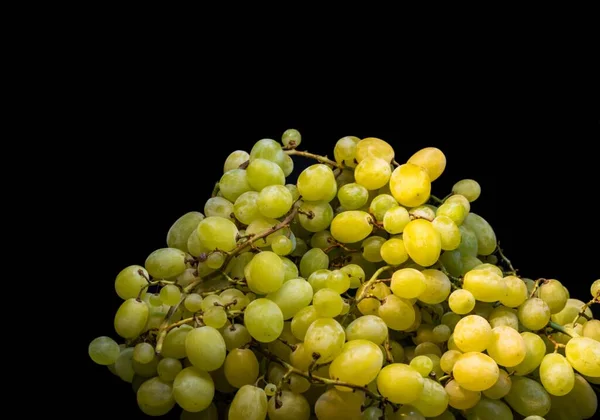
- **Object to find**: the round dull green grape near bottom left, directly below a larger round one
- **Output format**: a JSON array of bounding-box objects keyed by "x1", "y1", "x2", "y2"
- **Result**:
[{"x1": 173, "y1": 367, "x2": 215, "y2": 413}]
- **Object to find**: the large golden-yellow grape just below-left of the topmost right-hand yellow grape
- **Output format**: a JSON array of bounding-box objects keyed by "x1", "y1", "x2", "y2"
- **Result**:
[{"x1": 390, "y1": 163, "x2": 431, "y2": 207}]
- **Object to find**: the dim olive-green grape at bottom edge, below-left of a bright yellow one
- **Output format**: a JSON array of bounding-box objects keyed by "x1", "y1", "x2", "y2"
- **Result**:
[{"x1": 504, "y1": 376, "x2": 551, "y2": 417}]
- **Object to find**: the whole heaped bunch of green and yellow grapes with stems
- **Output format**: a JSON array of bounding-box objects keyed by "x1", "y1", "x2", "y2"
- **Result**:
[{"x1": 89, "y1": 129, "x2": 600, "y2": 420}]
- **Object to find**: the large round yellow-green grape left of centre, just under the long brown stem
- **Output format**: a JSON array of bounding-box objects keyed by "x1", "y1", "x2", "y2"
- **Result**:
[{"x1": 245, "y1": 251, "x2": 285, "y2": 295}]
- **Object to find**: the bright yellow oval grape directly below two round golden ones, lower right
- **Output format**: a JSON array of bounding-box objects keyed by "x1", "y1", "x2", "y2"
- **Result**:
[{"x1": 452, "y1": 351, "x2": 500, "y2": 391}]
